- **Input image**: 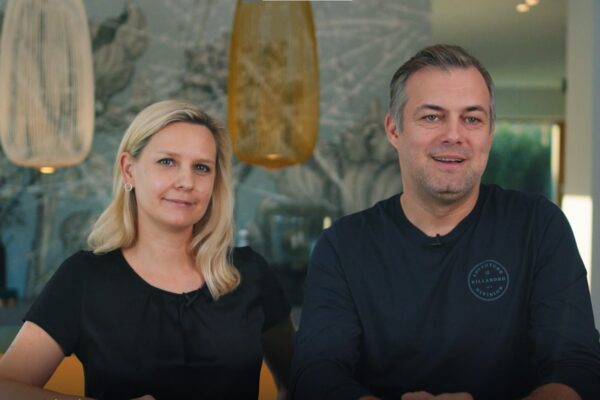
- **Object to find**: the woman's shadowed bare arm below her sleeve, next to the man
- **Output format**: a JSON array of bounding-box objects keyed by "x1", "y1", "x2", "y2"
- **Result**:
[{"x1": 262, "y1": 317, "x2": 294, "y2": 399}]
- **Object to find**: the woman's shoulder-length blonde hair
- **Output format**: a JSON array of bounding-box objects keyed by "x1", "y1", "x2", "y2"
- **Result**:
[{"x1": 88, "y1": 100, "x2": 240, "y2": 300}]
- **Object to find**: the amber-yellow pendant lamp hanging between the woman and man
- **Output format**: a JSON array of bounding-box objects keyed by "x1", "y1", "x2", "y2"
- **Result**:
[{"x1": 228, "y1": 0, "x2": 319, "y2": 168}]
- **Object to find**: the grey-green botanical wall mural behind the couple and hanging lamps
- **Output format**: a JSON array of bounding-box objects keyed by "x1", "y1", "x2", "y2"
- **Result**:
[{"x1": 0, "y1": 0, "x2": 430, "y2": 297}]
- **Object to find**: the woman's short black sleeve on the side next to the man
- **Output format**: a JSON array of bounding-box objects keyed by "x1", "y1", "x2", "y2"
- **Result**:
[{"x1": 245, "y1": 250, "x2": 291, "y2": 332}]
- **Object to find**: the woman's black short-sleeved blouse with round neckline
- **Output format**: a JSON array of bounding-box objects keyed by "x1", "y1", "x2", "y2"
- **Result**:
[{"x1": 25, "y1": 247, "x2": 290, "y2": 400}]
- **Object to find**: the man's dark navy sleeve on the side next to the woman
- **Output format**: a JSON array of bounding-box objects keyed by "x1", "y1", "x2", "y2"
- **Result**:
[{"x1": 290, "y1": 231, "x2": 370, "y2": 400}]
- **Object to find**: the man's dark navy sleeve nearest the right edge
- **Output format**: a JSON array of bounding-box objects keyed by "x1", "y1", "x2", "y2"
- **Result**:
[{"x1": 529, "y1": 205, "x2": 600, "y2": 400}]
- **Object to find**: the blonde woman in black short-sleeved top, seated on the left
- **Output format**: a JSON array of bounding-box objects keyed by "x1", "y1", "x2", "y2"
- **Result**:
[{"x1": 0, "y1": 101, "x2": 293, "y2": 399}]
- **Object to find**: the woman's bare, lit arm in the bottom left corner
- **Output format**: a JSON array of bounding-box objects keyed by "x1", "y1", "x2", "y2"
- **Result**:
[{"x1": 0, "y1": 321, "x2": 93, "y2": 400}]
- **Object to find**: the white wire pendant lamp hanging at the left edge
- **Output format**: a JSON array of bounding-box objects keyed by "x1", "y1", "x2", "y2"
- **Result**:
[{"x1": 0, "y1": 0, "x2": 94, "y2": 172}]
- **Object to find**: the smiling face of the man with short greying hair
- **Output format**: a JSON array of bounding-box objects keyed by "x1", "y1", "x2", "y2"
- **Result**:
[{"x1": 386, "y1": 67, "x2": 493, "y2": 202}]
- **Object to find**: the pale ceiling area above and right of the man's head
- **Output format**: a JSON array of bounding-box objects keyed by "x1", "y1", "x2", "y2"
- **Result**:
[{"x1": 431, "y1": 0, "x2": 567, "y2": 88}]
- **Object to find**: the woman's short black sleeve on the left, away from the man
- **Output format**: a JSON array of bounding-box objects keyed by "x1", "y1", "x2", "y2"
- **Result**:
[{"x1": 23, "y1": 252, "x2": 84, "y2": 356}]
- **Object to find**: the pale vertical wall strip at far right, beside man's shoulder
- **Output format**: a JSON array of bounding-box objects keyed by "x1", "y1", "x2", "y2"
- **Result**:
[{"x1": 563, "y1": 0, "x2": 600, "y2": 327}]
